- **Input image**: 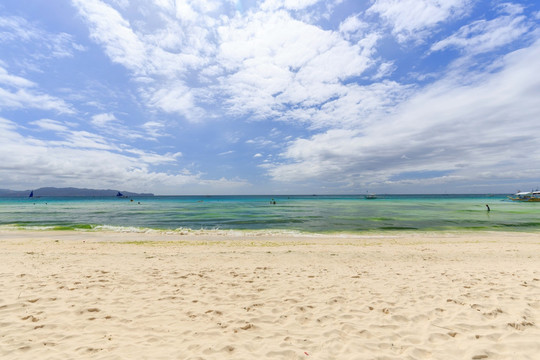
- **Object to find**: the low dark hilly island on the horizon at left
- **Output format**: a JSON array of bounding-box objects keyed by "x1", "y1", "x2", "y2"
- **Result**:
[{"x1": 0, "y1": 187, "x2": 154, "y2": 197}]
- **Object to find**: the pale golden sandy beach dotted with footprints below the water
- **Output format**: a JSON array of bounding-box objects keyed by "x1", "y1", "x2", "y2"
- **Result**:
[{"x1": 0, "y1": 231, "x2": 540, "y2": 360}]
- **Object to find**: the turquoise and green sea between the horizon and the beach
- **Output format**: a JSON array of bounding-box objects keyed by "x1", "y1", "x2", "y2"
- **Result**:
[{"x1": 0, "y1": 195, "x2": 540, "y2": 233}]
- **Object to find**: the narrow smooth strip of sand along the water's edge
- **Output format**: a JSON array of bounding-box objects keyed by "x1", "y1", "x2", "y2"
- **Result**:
[{"x1": 0, "y1": 228, "x2": 540, "y2": 246}]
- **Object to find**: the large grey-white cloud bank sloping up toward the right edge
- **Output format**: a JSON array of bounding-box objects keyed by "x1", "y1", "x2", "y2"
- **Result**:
[{"x1": 265, "y1": 42, "x2": 540, "y2": 190}]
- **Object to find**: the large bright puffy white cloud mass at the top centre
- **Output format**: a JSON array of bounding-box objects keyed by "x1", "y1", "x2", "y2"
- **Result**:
[{"x1": 75, "y1": 0, "x2": 389, "y2": 122}]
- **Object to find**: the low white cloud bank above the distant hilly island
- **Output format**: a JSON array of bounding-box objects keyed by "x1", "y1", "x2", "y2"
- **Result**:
[{"x1": 0, "y1": 118, "x2": 249, "y2": 194}]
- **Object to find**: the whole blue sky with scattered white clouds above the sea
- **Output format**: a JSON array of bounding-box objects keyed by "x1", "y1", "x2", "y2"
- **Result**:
[{"x1": 0, "y1": 0, "x2": 540, "y2": 195}]
